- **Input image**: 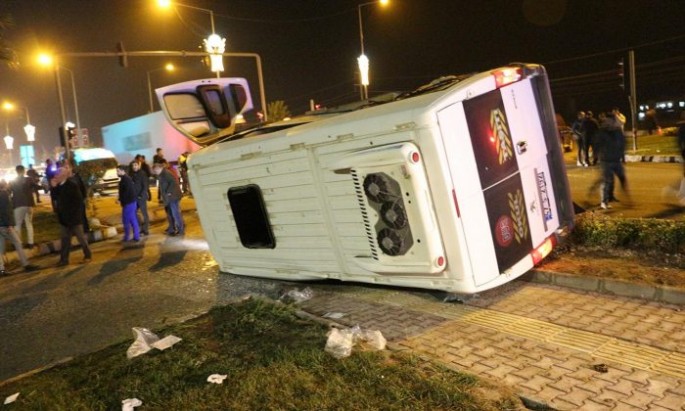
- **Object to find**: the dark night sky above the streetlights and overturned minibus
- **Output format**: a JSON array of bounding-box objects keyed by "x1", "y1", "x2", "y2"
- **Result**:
[{"x1": 0, "y1": 0, "x2": 685, "y2": 150}]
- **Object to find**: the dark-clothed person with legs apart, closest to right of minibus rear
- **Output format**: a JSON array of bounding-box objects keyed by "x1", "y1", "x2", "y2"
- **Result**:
[{"x1": 600, "y1": 114, "x2": 628, "y2": 210}]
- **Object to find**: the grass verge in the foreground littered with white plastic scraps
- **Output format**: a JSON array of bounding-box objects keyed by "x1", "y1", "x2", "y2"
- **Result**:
[{"x1": 0, "y1": 299, "x2": 521, "y2": 411}]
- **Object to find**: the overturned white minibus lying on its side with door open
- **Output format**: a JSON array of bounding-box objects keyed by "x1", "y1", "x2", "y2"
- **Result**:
[{"x1": 157, "y1": 64, "x2": 573, "y2": 293}]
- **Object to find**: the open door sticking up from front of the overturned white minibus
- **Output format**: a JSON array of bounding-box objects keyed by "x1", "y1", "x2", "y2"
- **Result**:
[{"x1": 156, "y1": 78, "x2": 253, "y2": 146}]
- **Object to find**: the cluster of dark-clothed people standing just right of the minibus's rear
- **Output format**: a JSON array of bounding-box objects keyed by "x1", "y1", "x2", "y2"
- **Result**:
[{"x1": 571, "y1": 108, "x2": 628, "y2": 209}]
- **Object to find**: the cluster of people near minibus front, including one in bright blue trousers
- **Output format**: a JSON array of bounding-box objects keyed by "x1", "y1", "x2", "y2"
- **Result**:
[{"x1": 117, "y1": 148, "x2": 187, "y2": 243}]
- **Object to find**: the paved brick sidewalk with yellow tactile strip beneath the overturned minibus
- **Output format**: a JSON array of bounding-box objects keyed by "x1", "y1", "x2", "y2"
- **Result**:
[{"x1": 301, "y1": 281, "x2": 685, "y2": 410}]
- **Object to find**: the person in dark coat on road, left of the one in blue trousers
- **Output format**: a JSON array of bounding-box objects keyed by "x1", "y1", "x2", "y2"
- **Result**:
[{"x1": 51, "y1": 167, "x2": 92, "y2": 267}]
